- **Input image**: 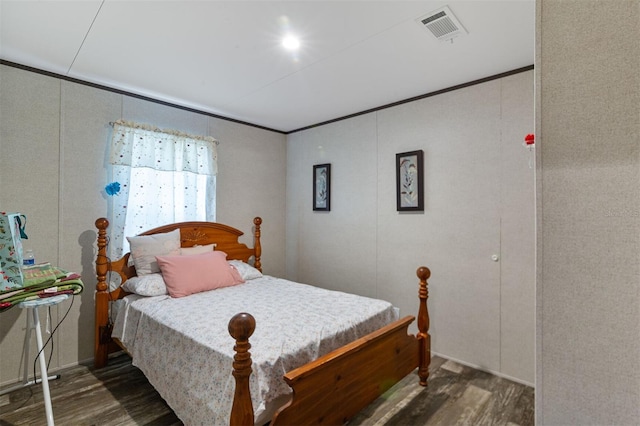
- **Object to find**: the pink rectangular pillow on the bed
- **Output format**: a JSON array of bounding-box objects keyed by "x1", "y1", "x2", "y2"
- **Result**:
[{"x1": 156, "y1": 251, "x2": 244, "y2": 297}]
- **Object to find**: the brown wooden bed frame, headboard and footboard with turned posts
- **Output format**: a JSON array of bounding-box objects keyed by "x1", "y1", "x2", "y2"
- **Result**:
[{"x1": 94, "y1": 217, "x2": 431, "y2": 425}]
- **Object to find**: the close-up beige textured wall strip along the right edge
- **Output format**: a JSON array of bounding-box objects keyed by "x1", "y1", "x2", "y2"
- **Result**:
[{"x1": 536, "y1": 0, "x2": 640, "y2": 425}]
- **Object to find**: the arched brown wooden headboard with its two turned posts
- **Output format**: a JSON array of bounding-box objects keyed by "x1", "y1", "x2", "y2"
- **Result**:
[{"x1": 94, "y1": 217, "x2": 262, "y2": 367}]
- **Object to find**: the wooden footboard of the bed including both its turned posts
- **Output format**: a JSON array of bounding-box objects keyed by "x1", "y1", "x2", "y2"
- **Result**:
[{"x1": 229, "y1": 267, "x2": 431, "y2": 425}]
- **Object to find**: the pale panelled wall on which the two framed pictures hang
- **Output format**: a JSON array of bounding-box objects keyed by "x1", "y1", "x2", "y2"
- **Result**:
[{"x1": 287, "y1": 71, "x2": 535, "y2": 383}]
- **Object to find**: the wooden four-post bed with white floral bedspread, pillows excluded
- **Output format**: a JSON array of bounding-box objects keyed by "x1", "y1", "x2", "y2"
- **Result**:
[{"x1": 95, "y1": 217, "x2": 430, "y2": 425}]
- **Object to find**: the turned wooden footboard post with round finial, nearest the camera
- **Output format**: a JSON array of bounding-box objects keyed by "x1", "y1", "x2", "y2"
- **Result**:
[{"x1": 229, "y1": 312, "x2": 259, "y2": 426}]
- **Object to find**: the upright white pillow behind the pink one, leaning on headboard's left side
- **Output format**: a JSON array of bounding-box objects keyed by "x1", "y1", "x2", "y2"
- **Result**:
[{"x1": 127, "y1": 229, "x2": 180, "y2": 276}]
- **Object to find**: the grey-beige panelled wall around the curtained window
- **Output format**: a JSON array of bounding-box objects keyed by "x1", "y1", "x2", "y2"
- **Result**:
[{"x1": 0, "y1": 66, "x2": 286, "y2": 384}]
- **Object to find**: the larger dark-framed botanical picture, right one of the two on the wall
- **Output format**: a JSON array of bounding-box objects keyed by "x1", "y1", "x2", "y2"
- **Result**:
[{"x1": 396, "y1": 149, "x2": 424, "y2": 212}]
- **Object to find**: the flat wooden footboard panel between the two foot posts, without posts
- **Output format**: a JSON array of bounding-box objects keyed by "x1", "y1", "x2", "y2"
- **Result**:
[{"x1": 271, "y1": 316, "x2": 421, "y2": 426}]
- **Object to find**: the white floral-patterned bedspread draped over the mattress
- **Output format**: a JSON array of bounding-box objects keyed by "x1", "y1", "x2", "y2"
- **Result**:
[{"x1": 113, "y1": 276, "x2": 398, "y2": 425}]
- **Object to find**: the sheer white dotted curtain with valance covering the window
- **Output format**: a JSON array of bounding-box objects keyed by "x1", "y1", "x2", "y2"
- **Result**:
[{"x1": 109, "y1": 120, "x2": 218, "y2": 259}]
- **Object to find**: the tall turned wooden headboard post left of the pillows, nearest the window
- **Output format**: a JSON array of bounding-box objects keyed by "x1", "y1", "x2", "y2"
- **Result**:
[{"x1": 93, "y1": 217, "x2": 109, "y2": 368}]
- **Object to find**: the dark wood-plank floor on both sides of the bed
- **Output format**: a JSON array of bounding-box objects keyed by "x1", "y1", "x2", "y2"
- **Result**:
[{"x1": 0, "y1": 355, "x2": 534, "y2": 426}]
